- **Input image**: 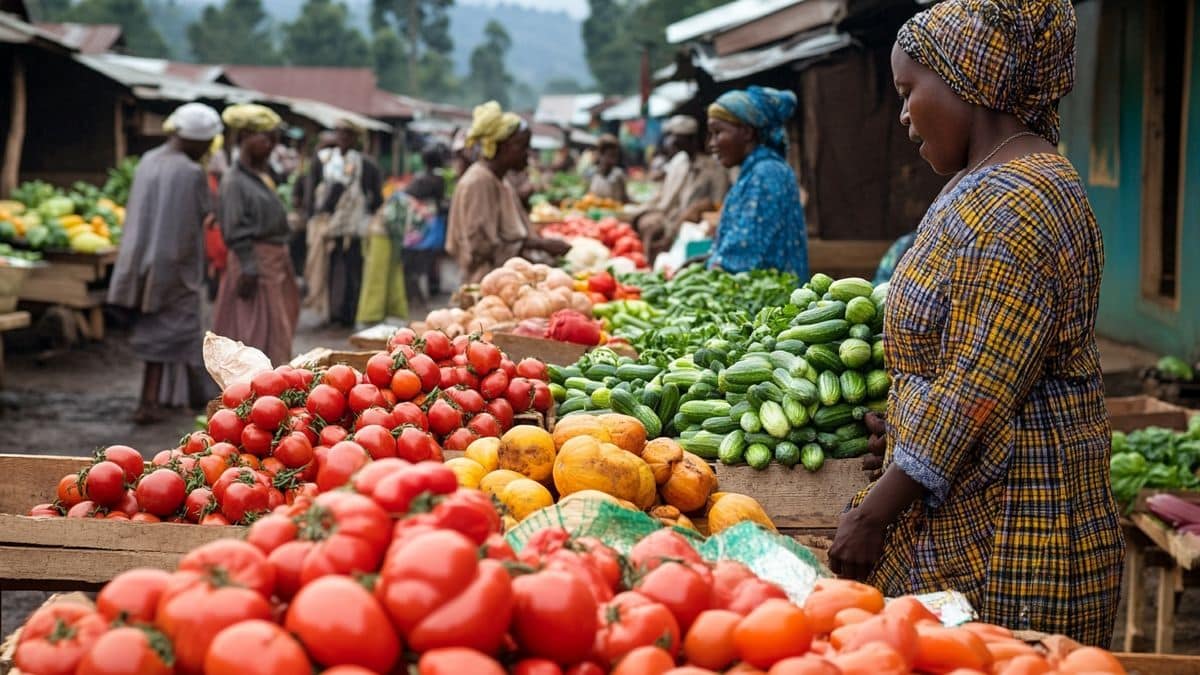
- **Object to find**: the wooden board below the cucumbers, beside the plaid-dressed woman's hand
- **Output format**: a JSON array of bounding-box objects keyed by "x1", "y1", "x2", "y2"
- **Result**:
[{"x1": 716, "y1": 459, "x2": 868, "y2": 528}]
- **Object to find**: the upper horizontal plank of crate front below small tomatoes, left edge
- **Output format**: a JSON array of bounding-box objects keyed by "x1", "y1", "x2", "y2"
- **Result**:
[{"x1": 0, "y1": 514, "x2": 246, "y2": 554}]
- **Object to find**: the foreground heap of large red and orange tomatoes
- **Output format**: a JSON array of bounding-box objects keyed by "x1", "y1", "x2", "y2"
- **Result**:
[{"x1": 13, "y1": 475, "x2": 1124, "y2": 675}]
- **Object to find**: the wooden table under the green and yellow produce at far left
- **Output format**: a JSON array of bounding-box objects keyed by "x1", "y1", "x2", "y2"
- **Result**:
[{"x1": 18, "y1": 249, "x2": 116, "y2": 341}]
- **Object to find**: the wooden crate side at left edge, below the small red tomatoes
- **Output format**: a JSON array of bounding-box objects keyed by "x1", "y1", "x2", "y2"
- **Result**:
[{"x1": 0, "y1": 454, "x2": 245, "y2": 590}]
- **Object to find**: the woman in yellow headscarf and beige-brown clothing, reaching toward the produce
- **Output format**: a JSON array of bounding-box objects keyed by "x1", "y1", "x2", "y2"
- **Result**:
[{"x1": 446, "y1": 101, "x2": 570, "y2": 283}]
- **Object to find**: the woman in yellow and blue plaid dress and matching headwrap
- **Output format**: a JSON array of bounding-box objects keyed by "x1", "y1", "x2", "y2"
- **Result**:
[{"x1": 829, "y1": 0, "x2": 1124, "y2": 646}]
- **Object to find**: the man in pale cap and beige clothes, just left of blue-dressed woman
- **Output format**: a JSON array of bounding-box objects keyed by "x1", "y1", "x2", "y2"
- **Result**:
[{"x1": 634, "y1": 115, "x2": 730, "y2": 257}]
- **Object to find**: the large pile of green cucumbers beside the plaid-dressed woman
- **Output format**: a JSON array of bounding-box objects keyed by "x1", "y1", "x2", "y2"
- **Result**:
[{"x1": 550, "y1": 274, "x2": 890, "y2": 471}]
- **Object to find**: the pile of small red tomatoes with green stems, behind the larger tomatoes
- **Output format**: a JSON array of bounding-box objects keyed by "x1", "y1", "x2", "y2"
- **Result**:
[{"x1": 30, "y1": 329, "x2": 553, "y2": 525}]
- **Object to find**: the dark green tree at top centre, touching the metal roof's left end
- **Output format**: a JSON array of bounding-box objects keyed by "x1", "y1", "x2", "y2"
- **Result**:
[{"x1": 581, "y1": 0, "x2": 727, "y2": 94}]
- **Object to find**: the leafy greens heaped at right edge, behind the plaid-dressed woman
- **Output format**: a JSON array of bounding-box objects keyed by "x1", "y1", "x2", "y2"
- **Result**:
[{"x1": 1109, "y1": 416, "x2": 1200, "y2": 508}]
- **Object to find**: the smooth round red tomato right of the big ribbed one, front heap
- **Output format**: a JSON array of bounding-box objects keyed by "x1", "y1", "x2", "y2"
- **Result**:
[{"x1": 512, "y1": 571, "x2": 596, "y2": 663}]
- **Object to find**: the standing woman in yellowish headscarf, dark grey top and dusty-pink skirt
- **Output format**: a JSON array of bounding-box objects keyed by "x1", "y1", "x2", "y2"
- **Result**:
[{"x1": 212, "y1": 103, "x2": 300, "y2": 365}]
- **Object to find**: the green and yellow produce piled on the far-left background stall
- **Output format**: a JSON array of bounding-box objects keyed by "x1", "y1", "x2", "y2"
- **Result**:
[{"x1": 0, "y1": 180, "x2": 125, "y2": 253}]
